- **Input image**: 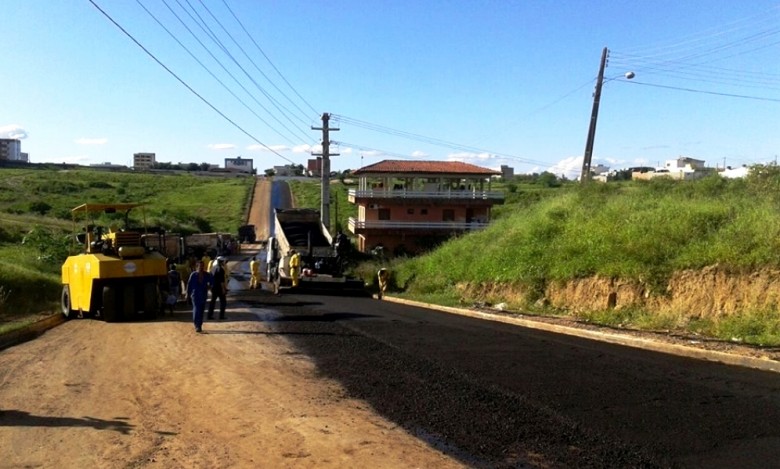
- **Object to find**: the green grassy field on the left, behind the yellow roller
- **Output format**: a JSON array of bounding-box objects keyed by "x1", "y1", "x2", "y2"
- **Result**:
[{"x1": 0, "y1": 168, "x2": 254, "y2": 332}]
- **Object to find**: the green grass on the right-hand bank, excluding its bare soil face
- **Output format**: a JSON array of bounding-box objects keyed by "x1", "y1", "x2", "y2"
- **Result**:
[{"x1": 293, "y1": 170, "x2": 780, "y2": 345}]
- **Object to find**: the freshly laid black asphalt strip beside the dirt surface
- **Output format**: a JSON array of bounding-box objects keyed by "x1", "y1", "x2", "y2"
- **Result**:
[{"x1": 236, "y1": 292, "x2": 780, "y2": 468}]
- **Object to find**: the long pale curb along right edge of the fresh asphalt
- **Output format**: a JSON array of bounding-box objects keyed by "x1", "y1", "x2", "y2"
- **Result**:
[{"x1": 382, "y1": 296, "x2": 780, "y2": 373}]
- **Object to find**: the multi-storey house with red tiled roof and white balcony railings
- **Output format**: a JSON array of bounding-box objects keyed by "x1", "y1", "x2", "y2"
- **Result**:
[{"x1": 349, "y1": 160, "x2": 504, "y2": 254}]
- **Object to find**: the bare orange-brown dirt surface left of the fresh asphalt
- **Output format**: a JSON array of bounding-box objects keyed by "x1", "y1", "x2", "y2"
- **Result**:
[{"x1": 0, "y1": 309, "x2": 459, "y2": 468}]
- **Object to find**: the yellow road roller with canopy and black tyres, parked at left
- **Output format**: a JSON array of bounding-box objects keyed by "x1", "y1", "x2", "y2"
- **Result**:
[{"x1": 62, "y1": 203, "x2": 167, "y2": 322}]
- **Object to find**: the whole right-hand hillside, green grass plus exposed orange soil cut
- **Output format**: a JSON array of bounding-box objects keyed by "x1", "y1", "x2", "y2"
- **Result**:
[{"x1": 293, "y1": 170, "x2": 780, "y2": 345}]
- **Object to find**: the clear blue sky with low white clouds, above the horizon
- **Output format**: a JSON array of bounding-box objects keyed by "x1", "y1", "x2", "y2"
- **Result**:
[{"x1": 0, "y1": 0, "x2": 780, "y2": 179}]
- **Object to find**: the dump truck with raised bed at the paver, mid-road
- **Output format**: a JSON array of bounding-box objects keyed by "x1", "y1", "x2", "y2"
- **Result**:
[{"x1": 266, "y1": 208, "x2": 364, "y2": 289}]
